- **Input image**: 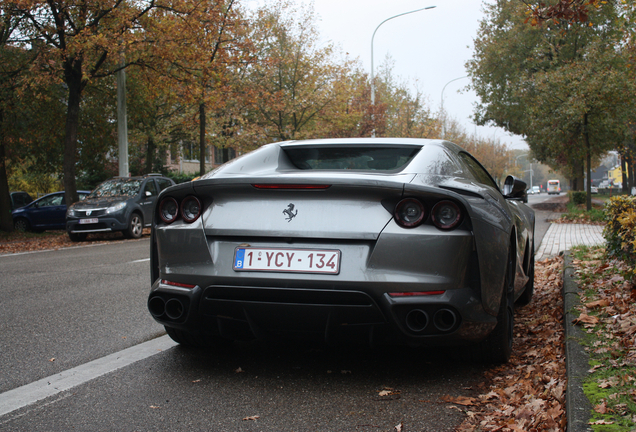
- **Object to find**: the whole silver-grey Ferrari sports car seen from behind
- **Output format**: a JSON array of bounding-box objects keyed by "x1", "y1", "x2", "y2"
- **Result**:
[{"x1": 148, "y1": 138, "x2": 534, "y2": 362}]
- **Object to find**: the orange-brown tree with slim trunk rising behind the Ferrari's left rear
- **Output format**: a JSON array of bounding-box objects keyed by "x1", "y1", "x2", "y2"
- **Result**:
[{"x1": 143, "y1": 0, "x2": 251, "y2": 173}]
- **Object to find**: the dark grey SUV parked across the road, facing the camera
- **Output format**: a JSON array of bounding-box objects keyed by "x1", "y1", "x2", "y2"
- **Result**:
[{"x1": 66, "y1": 174, "x2": 174, "y2": 241}]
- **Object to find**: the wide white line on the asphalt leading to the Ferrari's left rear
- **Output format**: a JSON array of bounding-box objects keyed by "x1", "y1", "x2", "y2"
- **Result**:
[{"x1": 0, "y1": 335, "x2": 177, "y2": 417}]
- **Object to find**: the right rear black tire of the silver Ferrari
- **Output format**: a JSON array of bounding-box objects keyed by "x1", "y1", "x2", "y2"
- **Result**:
[{"x1": 469, "y1": 245, "x2": 515, "y2": 364}]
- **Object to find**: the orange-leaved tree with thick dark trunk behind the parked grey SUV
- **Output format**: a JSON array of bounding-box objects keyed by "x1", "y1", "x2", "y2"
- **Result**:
[{"x1": 9, "y1": 0, "x2": 156, "y2": 203}]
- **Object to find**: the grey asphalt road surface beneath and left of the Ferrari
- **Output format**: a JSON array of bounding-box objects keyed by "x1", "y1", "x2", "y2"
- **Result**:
[{"x1": 0, "y1": 196, "x2": 547, "y2": 432}]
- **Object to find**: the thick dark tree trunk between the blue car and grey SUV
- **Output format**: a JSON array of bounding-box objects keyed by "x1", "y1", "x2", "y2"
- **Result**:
[{"x1": 63, "y1": 69, "x2": 83, "y2": 206}]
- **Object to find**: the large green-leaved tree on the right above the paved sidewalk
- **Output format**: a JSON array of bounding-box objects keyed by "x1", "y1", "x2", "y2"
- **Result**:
[{"x1": 467, "y1": 0, "x2": 630, "y2": 209}]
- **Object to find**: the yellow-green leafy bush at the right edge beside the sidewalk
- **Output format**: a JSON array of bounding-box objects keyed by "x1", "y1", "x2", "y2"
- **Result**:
[{"x1": 603, "y1": 195, "x2": 636, "y2": 274}]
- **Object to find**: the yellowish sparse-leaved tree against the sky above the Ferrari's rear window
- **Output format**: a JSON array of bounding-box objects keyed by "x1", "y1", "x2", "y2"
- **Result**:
[{"x1": 249, "y1": 4, "x2": 338, "y2": 140}]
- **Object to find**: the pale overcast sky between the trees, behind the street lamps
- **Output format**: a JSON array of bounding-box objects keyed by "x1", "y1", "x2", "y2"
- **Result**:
[{"x1": 253, "y1": 0, "x2": 527, "y2": 148}]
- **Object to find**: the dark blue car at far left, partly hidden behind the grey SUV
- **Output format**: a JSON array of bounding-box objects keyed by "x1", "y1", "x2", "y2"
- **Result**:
[{"x1": 11, "y1": 191, "x2": 91, "y2": 232}]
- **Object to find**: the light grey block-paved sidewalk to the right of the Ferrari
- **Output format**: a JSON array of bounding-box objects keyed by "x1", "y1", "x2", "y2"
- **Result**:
[{"x1": 535, "y1": 223, "x2": 605, "y2": 261}]
